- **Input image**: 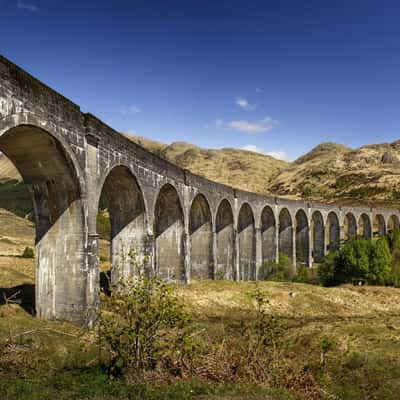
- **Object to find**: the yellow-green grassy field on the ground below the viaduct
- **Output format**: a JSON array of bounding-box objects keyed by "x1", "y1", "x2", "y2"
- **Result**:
[{"x1": 0, "y1": 212, "x2": 400, "y2": 400}]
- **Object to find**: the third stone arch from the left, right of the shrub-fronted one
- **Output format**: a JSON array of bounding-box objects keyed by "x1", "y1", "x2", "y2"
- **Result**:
[{"x1": 154, "y1": 183, "x2": 185, "y2": 281}]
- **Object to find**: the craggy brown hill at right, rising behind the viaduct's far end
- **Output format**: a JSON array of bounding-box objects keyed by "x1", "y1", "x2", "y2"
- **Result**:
[{"x1": 270, "y1": 141, "x2": 400, "y2": 206}]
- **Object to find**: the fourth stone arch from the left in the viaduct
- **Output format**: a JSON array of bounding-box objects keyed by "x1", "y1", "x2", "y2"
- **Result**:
[{"x1": 189, "y1": 194, "x2": 213, "y2": 279}]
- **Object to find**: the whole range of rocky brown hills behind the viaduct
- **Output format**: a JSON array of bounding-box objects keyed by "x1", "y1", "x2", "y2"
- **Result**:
[{"x1": 0, "y1": 135, "x2": 400, "y2": 206}]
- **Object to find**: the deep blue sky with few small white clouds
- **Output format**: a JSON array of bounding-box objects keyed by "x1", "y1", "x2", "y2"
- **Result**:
[{"x1": 0, "y1": 0, "x2": 400, "y2": 159}]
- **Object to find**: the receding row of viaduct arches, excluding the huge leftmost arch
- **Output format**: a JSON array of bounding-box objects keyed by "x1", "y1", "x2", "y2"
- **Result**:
[{"x1": 99, "y1": 167, "x2": 399, "y2": 281}]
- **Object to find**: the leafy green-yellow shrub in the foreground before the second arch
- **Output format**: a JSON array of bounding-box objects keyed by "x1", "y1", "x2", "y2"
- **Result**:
[{"x1": 98, "y1": 273, "x2": 196, "y2": 379}]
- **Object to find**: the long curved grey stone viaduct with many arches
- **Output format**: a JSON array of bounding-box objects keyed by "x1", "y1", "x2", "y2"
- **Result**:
[{"x1": 0, "y1": 56, "x2": 399, "y2": 325}]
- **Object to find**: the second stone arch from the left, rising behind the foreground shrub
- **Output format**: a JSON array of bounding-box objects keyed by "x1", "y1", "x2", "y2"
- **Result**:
[{"x1": 100, "y1": 165, "x2": 148, "y2": 283}]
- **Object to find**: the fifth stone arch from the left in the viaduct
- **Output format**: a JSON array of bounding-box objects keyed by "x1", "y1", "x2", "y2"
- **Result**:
[{"x1": 214, "y1": 199, "x2": 235, "y2": 279}]
